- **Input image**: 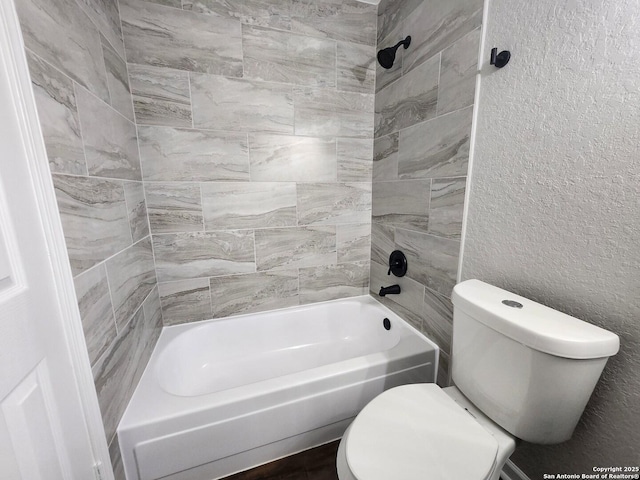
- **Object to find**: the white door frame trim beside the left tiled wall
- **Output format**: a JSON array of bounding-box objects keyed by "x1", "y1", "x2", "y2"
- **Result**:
[{"x1": 0, "y1": 0, "x2": 114, "y2": 480}]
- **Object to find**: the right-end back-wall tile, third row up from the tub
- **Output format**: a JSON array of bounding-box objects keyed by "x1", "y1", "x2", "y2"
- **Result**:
[{"x1": 298, "y1": 182, "x2": 371, "y2": 225}]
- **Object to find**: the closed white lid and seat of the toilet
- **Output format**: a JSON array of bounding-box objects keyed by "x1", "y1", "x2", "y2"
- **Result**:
[{"x1": 345, "y1": 384, "x2": 498, "y2": 480}]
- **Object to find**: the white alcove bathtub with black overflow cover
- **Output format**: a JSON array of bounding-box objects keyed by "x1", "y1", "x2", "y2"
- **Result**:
[{"x1": 118, "y1": 296, "x2": 438, "y2": 480}]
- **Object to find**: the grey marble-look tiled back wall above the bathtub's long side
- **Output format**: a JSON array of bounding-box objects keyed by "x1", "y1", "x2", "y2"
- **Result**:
[{"x1": 120, "y1": 0, "x2": 376, "y2": 325}]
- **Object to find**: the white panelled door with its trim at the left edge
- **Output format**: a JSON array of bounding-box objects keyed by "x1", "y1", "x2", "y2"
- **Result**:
[{"x1": 0, "y1": 0, "x2": 112, "y2": 480}]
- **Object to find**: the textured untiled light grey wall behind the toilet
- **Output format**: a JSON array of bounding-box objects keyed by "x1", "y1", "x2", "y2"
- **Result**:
[{"x1": 461, "y1": 0, "x2": 640, "y2": 479}]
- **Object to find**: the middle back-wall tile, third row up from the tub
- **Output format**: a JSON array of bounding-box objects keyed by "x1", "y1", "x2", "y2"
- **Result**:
[{"x1": 201, "y1": 182, "x2": 296, "y2": 231}]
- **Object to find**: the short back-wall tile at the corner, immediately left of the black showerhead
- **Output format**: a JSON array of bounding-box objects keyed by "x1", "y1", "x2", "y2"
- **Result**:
[{"x1": 337, "y1": 42, "x2": 378, "y2": 93}]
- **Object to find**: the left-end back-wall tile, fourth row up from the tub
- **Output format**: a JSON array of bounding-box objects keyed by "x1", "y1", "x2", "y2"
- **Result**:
[{"x1": 138, "y1": 127, "x2": 249, "y2": 182}]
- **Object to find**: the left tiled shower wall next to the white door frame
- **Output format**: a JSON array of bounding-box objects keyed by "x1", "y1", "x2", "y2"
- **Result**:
[{"x1": 15, "y1": 0, "x2": 162, "y2": 468}]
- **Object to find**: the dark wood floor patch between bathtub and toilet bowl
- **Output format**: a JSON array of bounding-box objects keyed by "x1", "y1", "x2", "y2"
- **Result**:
[{"x1": 224, "y1": 441, "x2": 340, "y2": 480}]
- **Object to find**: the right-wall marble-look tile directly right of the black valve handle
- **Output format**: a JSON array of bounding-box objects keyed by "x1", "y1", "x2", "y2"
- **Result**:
[{"x1": 395, "y1": 228, "x2": 460, "y2": 297}]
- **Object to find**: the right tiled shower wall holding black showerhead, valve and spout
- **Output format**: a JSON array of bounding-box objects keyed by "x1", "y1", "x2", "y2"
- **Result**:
[{"x1": 371, "y1": 0, "x2": 483, "y2": 384}]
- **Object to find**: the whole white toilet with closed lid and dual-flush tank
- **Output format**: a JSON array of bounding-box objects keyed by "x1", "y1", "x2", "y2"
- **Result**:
[{"x1": 337, "y1": 280, "x2": 619, "y2": 480}]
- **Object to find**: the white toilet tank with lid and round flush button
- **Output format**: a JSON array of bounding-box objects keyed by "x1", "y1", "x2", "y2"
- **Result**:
[{"x1": 452, "y1": 280, "x2": 619, "y2": 444}]
